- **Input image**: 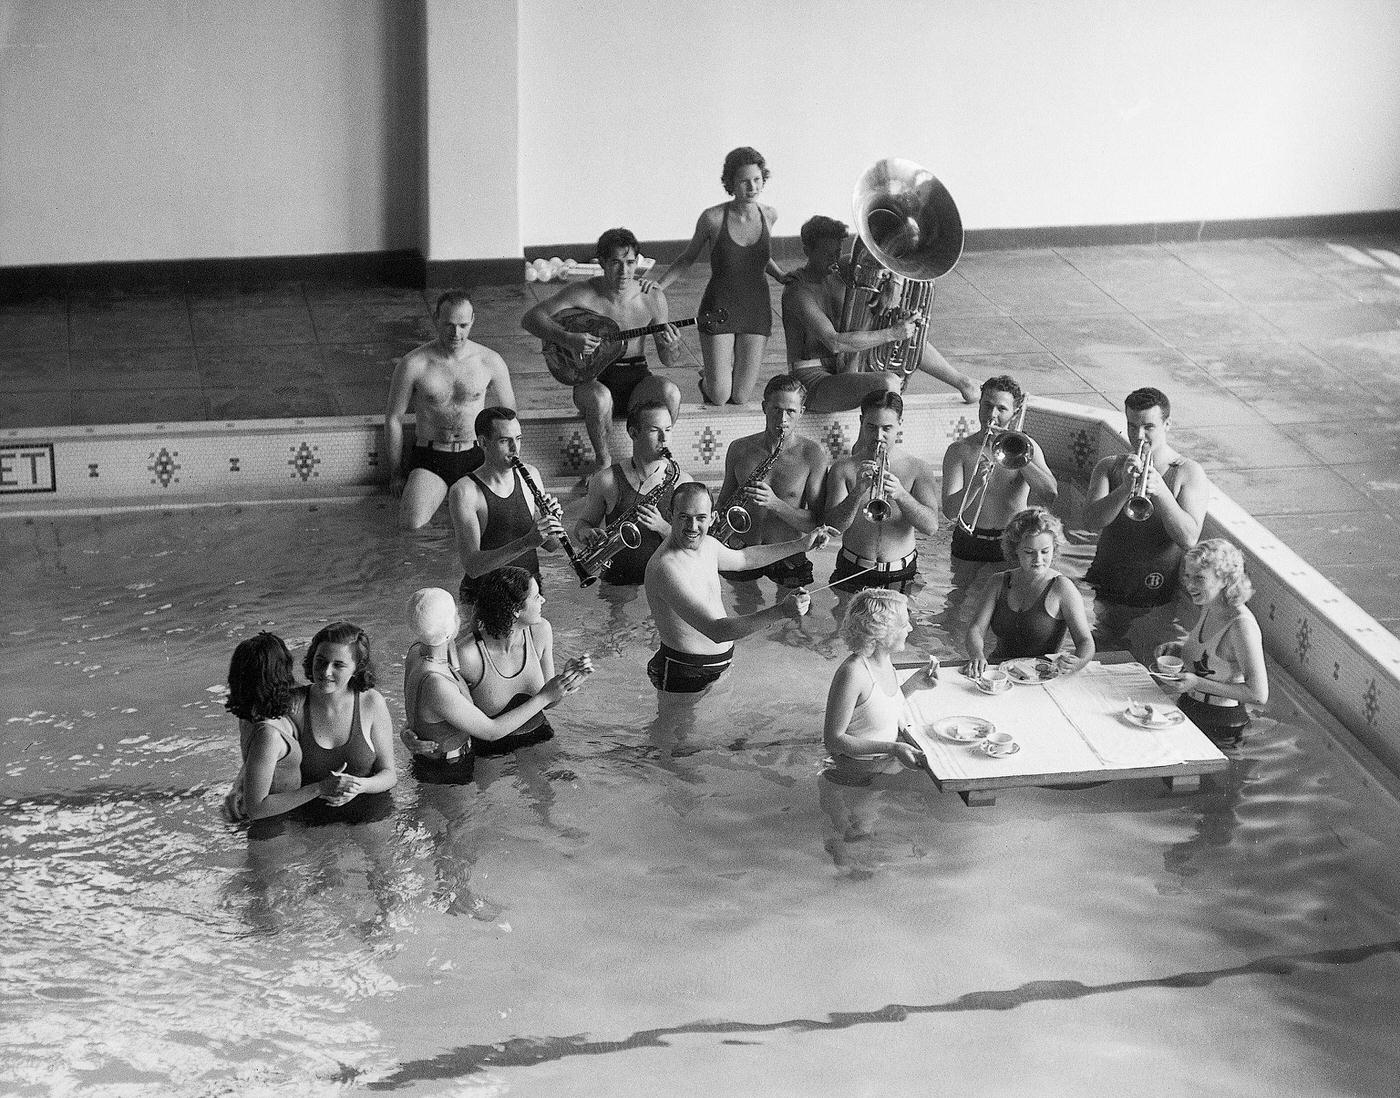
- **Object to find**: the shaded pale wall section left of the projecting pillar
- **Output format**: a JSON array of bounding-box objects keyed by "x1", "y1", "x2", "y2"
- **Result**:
[{"x1": 0, "y1": 0, "x2": 421, "y2": 266}]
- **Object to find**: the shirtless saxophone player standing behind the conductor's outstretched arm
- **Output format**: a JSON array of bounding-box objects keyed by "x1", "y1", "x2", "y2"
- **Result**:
[{"x1": 715, "y1": 374, "x2": 830, "y2": 587}]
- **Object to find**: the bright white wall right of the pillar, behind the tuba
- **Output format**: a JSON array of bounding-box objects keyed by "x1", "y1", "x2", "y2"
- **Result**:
[{"x1": 519, "y1": 0, "x2": 1400, "y2": 244}]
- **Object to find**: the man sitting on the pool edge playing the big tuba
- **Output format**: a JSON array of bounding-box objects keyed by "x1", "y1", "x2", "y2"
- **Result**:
[{"x1": 783, "y1": 214, "x2": 977, "y2": 412}]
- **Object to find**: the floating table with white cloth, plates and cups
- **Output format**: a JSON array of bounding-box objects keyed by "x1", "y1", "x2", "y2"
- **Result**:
[{"x1": 900, "y1": 653, "x2": 1229, "y2": 804}]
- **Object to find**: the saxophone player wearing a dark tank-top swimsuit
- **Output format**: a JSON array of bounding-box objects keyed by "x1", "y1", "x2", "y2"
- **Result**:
[{"x1": 574, "y1": 401, "x2": 690, "y2": 584}]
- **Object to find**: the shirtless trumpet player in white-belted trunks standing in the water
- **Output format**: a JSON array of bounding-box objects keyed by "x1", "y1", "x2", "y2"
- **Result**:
[{"x1": 822, "y1": 389, "x2": 938, "y2": 594}]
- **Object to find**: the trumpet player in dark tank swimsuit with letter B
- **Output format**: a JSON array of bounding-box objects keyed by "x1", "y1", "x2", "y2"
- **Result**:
[{"x1": 1084, "y1": 388, "x2": 1211, "y2": 657}]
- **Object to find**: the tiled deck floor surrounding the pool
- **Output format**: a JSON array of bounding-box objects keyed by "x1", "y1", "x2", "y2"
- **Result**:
[{"x1": 0, "y1": 237, "x2": 1400, "y2": 633}]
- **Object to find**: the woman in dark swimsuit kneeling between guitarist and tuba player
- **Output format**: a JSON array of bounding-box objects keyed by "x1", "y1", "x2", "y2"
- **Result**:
[{"x1": 644, "y1": 146, "x2": 794, "y2": 405}]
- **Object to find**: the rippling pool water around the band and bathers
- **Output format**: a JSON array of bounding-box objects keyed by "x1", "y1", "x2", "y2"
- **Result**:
[{"x1": 0, "y1": 500, "x2": 1400, "y2": 1095}]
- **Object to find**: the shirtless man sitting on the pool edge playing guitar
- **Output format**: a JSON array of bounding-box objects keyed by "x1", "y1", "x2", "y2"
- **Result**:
[{"x1": 521, "y1": 228, "x2": 680, "y2": 471}]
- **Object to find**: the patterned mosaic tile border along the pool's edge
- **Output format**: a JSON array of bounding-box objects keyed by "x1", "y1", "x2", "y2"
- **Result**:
[{"x1": 0, "y1": 395, "x2": 1400, "y2": 774}]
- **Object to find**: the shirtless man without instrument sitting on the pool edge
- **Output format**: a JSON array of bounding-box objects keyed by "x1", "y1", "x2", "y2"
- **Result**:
[{"x1": 384, "y1": 290, "x2": 515, "y2": 529}]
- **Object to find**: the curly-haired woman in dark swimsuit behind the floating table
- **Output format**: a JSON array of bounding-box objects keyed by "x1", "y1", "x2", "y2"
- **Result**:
[{"x1": 965, "y1": 507, "x2": 1093, "y2": 681}]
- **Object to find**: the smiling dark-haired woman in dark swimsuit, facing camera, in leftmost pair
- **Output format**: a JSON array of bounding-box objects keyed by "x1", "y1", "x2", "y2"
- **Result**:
[{"x1": 298, "y1": 622, "x2": 399, "y2": 808}]
